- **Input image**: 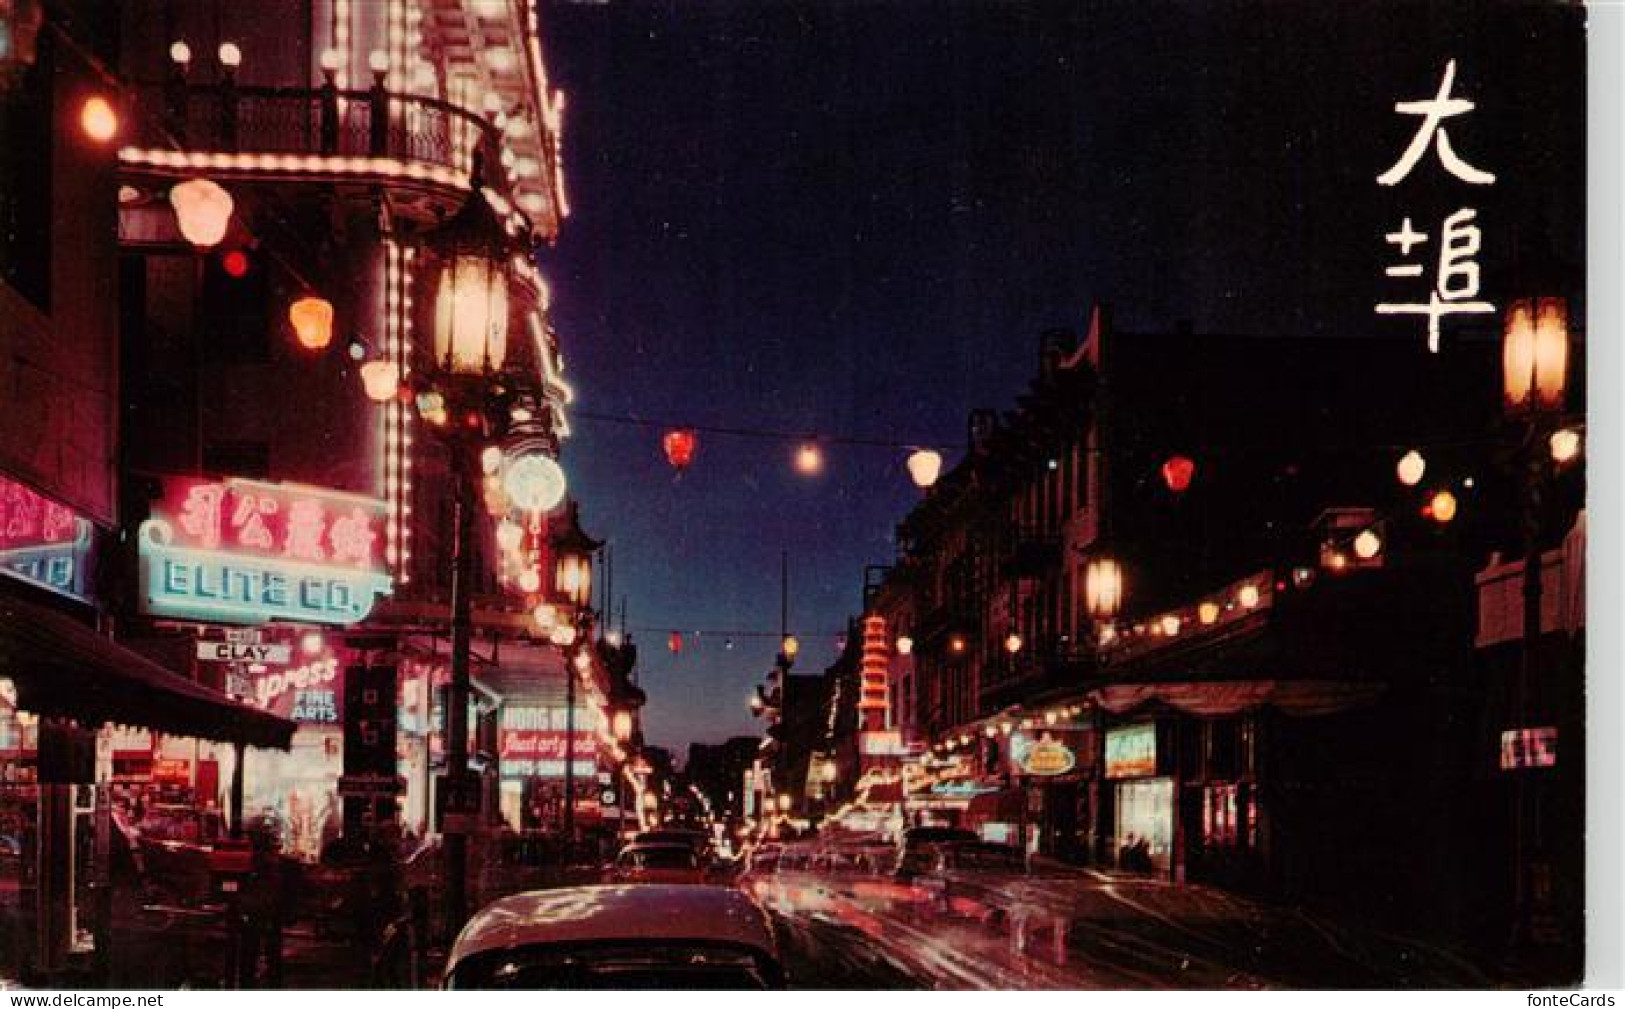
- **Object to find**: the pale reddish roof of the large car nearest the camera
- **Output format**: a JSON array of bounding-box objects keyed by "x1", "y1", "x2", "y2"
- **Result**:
[{"x1": 447, "y1": 884, "x2": 777, "y2": 970}]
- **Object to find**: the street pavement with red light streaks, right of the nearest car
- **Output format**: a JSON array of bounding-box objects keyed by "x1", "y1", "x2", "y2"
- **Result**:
[{"x1": 741, "y1": 871, "x2": 1493, "y2": 990}]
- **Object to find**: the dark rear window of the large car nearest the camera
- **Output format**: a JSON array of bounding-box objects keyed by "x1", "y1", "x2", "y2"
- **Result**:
[{"x1": 447, "y1": 941, "x2": 778, "y2": 991}]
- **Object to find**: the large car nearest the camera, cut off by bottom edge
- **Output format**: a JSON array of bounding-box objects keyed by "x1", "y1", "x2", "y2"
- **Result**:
[{"x1": 445, "y1": 886, "x2": 785, "y2": 991}]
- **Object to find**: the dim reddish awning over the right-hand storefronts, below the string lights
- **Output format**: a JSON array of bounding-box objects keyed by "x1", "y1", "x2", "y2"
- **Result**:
[{"x1": 1089, "y1": 679, "x2": 1383, "y2": 718}]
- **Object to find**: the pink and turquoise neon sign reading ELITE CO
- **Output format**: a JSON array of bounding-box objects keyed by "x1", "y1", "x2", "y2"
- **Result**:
[{"x1": 140, "y1": 479, "x2": 390, "y2": 624}]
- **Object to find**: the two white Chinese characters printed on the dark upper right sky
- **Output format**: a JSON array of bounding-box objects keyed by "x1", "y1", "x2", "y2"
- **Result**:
[{"x1": 1376, "y1": 60, "x2": 1495, "y2": 354}]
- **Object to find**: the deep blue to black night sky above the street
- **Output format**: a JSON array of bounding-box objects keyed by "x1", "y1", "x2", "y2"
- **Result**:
[{"x1": 541, "y1": 0, "x2": 1584, "y2": 747}]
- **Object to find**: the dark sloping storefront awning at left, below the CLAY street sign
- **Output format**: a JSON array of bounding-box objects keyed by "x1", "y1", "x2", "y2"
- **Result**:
[{"x1": 0, "y1": 595, "x2": 294, "y2": 749}]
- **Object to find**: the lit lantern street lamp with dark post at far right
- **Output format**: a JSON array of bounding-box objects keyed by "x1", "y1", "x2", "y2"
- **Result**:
[{"x1": 1502, "y1": 290, "x2": 1568, "y2": 938}]
